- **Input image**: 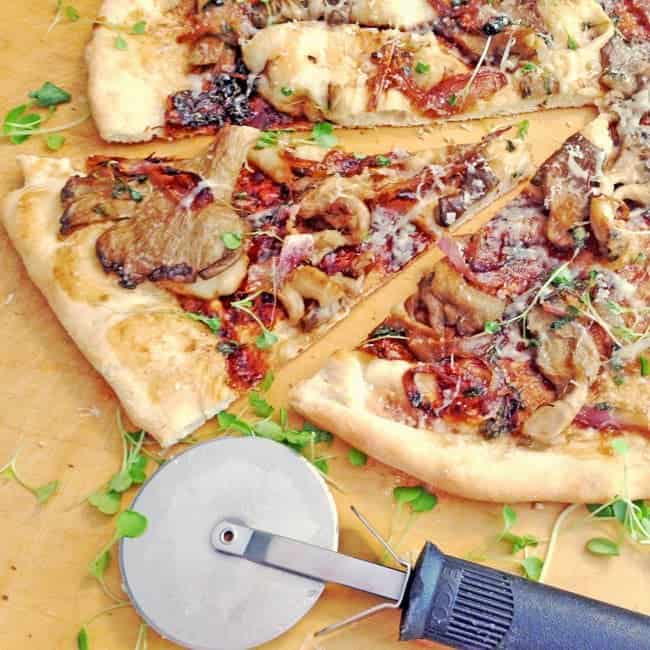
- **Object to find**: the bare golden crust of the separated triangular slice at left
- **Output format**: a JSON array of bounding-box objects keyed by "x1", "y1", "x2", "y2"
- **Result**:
[{"x1": 2, "y1": 156, "x2": 235, "y2": 446}]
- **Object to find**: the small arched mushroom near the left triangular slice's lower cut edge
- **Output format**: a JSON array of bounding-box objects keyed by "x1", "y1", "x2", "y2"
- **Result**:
[{"x1": 278, "y1": 266, "x2": 345, "y2": 330}]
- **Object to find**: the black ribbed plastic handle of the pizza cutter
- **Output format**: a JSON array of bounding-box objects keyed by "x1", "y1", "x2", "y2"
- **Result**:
[{"x1": 400, "y1": 543, "x2": 650, "y2": 650}]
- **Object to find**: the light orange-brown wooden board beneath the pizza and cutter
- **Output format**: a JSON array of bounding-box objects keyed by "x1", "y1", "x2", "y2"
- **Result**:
[{"x1": 0, "y1": 0, "x2": 650, "y2": 650}]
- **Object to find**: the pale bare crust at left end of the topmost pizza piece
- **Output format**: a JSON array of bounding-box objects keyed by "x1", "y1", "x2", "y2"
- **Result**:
[{"x1": 86, "y1": 0, "x2": 191, "y2": 142}]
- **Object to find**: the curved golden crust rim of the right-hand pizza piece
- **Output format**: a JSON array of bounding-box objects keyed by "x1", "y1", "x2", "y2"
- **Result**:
[{"x1": 290, "y1": 352, "x2": 650, "y2": 503}]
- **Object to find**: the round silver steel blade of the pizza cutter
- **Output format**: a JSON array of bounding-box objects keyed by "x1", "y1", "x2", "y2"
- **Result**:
[{"x1": 120, "y1": 438, "x2": 338, "y2": 650}]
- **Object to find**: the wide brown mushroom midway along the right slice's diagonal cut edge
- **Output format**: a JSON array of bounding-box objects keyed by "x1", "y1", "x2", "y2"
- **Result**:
[{"x1": 420, "y1": 260, "x2": 505, "y2": 336}]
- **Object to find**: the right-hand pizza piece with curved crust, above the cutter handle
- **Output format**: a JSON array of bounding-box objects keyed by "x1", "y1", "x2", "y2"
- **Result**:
[{"x1": 291, "y1": 83, "x2": 650, "y2": 503}]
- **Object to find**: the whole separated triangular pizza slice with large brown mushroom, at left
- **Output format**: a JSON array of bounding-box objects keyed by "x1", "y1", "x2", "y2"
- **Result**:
[{"x1": 3, "y1": 121, "x2": 531, "y2": 446}]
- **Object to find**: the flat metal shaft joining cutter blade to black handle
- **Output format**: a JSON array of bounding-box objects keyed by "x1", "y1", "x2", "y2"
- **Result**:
[{"x1": 212, "y1": 521, "x2": 406, "y2": 602}]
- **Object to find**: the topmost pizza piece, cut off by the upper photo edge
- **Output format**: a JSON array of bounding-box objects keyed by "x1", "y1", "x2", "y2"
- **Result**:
[{"x1": 87, "y1": 0, "x2": 612, "y2": 142}]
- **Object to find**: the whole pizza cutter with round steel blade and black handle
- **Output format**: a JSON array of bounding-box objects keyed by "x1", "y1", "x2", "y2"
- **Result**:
[{"x1": 120, "y1": 438, "x2": 650, "y2": 650}]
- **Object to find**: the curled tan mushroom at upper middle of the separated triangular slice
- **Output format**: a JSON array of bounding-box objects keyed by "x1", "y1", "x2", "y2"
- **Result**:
[{"x1": 298, "y1": 176, "x2": 372, "y2": 244}]
